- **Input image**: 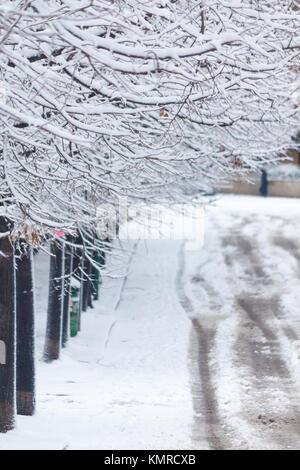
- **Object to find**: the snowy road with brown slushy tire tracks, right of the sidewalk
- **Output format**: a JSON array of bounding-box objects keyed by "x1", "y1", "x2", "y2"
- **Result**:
[{"x1": 182, "y1": 197, "x2": 300, "y2": 449}]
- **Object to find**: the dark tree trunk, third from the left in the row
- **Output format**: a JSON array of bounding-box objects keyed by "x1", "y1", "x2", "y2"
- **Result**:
[{"x1": 44, "y1": 242, "x2": 64, "y2": 362}]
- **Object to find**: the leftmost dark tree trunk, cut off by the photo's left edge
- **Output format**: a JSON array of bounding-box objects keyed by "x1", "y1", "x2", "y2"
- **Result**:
[{"x1": 0, "y1": 217, "x2": 16, "y2": 433}]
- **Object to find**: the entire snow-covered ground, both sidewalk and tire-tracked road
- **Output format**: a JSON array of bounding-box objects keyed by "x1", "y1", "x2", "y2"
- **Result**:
[{"x1": 0, "y1": 195, "x2": 300, "y2": 449}]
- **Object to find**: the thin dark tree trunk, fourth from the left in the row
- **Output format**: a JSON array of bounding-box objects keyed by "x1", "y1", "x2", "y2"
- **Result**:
[{"x1": 62, "y1": 239, "x2": 73, "y2": 348}]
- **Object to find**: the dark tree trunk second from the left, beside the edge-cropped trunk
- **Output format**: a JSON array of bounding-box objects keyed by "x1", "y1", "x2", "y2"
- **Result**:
[{"x1": 16, "y1": 247, "x2": 35, "y2": 416}]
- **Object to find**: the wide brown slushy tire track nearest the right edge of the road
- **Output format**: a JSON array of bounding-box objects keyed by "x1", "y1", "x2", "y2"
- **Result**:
[{"x1": 226, "y1": 236, "x2": 300, "y2": 449}]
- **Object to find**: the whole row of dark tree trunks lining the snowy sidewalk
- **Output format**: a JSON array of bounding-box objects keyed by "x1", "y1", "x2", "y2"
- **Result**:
[{"x1": 0, "y1": 217, "x2": 104, "y2": 433}]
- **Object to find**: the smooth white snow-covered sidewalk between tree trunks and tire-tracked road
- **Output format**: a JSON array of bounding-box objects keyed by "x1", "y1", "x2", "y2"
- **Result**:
[{"x1": 0, "y1": 241, "x2": 193, "y2": 449}]
